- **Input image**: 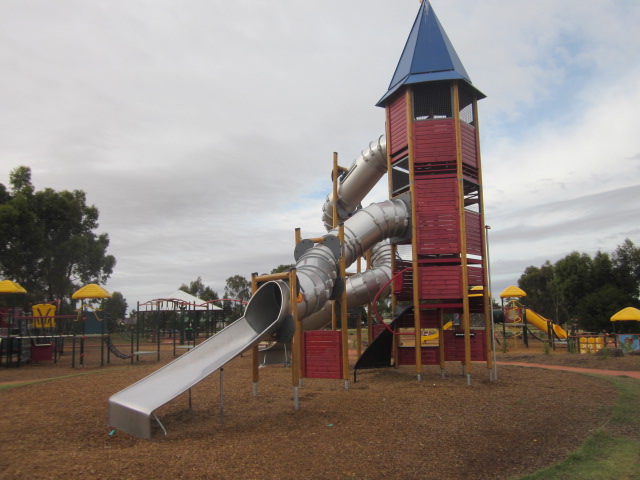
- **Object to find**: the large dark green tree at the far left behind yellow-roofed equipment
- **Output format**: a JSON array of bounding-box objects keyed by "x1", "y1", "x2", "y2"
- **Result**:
[{"x1": 0, "y1": 166, "x2": 116, "y2": 309}]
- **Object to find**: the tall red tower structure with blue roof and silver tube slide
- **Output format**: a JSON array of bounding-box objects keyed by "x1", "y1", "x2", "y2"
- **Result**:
[{"x1": 109, "y1": 2, "x2": 495, "y2": 439}]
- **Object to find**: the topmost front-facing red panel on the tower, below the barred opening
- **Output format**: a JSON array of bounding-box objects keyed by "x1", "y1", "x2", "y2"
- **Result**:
[{"x1": 413, "y1": 118, "x2": 456, "y2": 164}]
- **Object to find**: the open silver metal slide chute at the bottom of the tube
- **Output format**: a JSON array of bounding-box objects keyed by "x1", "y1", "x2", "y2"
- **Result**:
[{"x1": 109, "y1": 282, "x2": 289, "y2": 439}]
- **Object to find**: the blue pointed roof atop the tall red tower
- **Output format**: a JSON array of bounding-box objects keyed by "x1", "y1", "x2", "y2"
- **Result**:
[{"x1": 376, "y1": 0, "x2": 485, "y2": 107}]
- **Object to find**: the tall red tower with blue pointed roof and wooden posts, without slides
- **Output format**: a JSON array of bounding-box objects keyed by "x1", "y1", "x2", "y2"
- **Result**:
[{"x1": 370, "y1": 0, "x2": 494, "y2": 383}]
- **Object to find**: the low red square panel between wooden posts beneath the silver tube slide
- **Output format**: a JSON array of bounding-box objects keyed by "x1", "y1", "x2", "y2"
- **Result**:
[{"x1": 302, "y1": 330, "x2": 342, "y2": 378}]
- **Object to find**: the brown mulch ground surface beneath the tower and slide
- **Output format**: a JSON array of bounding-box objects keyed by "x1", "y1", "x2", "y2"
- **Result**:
[{"x1": 0, "y1": 349, "x2": 640, "y2": 479}]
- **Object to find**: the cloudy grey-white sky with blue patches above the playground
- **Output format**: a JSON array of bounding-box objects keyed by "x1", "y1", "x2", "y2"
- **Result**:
[{"x1": 0, "y1": 0, "x2": 640, "y2": 307}]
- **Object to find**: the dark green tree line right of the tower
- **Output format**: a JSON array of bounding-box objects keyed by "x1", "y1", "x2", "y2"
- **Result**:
[{"x1": 518, "y1": 238, "x2": 640, "y2": 332}]
